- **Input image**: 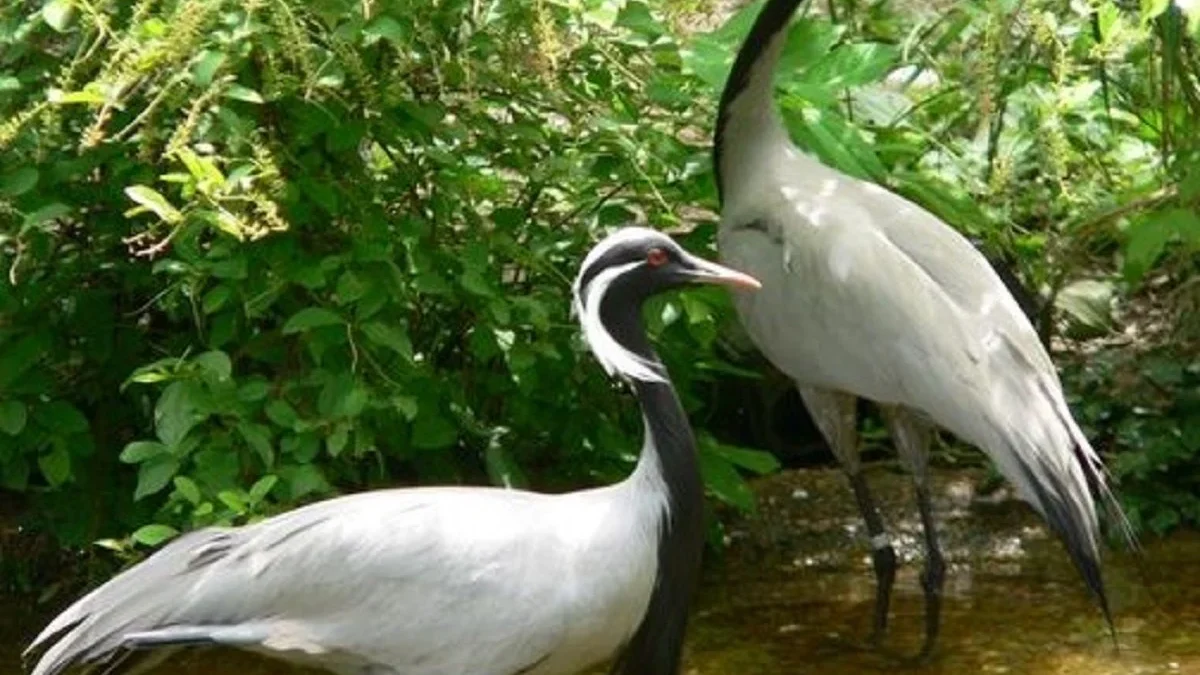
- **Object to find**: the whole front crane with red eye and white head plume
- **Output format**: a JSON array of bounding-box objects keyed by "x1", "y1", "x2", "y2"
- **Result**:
[{"x1": 26, "y1": 227, "x2": 758, "y2": 675}]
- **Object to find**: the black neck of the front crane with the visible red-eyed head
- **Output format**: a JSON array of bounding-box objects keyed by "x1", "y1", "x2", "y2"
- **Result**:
[{"x1": 600, "y1": 289, "x2": 704, "y2": 675}]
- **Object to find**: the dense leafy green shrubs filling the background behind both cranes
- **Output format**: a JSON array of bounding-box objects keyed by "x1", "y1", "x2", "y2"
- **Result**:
[{"x1": 0, "y1": 0, "x2": 1200, "y2": 581}]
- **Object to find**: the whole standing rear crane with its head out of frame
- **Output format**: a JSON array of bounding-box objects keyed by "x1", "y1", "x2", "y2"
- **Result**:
[{"x1": 713, "y1": 0, "x2": 1132, "y2": 658}]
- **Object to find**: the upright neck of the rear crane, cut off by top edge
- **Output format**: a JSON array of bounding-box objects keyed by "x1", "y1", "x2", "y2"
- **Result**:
[{"x1": 713, "y1": 0, "x2": 804, "y2": 205}]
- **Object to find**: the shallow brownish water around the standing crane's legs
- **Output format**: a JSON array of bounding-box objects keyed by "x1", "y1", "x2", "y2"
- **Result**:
[{"x1": 0, "y1": 466, "x2": 1200, "y2": 675}]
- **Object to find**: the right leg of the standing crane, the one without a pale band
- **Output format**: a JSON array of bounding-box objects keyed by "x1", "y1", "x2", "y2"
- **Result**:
[{"x1": 883, "y1": 406, "x2": 946, "y2": 661}]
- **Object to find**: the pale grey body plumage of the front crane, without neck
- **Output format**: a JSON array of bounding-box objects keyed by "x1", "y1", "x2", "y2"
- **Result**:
[{"x1": 34, "y1": 478, "x2": 664, "y2": 675}]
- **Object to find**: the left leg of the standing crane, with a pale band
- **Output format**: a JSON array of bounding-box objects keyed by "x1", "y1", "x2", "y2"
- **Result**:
[{"x1": 798, "y1": 387, "x2": 896, "y2": 644}]
